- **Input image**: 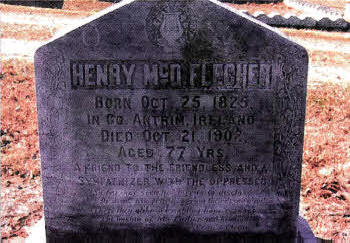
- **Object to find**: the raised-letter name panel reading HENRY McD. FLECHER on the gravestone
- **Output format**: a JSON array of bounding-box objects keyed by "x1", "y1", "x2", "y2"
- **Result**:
[{"x1": 70, "y1": 60, "x2": 274, "y2": 90}]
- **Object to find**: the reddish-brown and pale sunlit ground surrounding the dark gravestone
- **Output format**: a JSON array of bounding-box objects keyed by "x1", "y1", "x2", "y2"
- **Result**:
[{"x1": 0, "y1": 0, "x2": 350, "y2": 239}]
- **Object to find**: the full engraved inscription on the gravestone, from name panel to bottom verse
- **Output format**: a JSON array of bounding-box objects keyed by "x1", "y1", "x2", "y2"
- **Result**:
[{"x1": 63, "y1": 60, "x2": 274, "y2": 234}]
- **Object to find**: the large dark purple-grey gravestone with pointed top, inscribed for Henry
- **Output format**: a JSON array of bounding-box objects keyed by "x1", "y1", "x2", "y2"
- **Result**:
[{"x1": 35, "y1": 0, "x2": 308, "y2": 242}]
